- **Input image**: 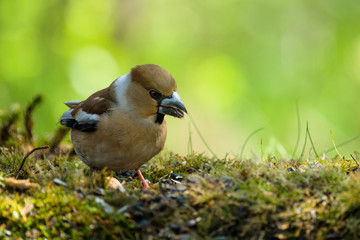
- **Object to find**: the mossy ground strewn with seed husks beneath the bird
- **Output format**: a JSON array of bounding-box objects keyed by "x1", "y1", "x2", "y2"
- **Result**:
[{"x1": 0, "y1": 99, "x2": 360, "y2": 239}]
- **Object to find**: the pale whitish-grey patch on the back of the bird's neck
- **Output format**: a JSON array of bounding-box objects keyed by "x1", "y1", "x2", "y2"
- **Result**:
[{"x1": 114, "y1": 73, "x2": 131, "y2": 112}]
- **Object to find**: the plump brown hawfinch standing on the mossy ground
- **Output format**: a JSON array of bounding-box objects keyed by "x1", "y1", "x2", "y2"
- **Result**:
[{"x1": 60, "y1": 64, "x2": 187, "y2": 188}]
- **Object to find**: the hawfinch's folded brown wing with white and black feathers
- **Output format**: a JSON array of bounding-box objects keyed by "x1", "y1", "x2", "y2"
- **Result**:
[{"x1": 60, "y1": 89, "x2": 115, "y2": 132}]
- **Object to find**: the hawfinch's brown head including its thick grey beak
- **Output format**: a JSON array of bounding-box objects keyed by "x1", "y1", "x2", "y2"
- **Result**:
[{"x1": 127, "y1": 64, "x2": 187, "y2": 124}]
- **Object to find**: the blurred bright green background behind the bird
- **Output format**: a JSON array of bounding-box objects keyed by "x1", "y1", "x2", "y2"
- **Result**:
[{"x1": 0, "y1": 0, "x2": 360, "y2": 157}]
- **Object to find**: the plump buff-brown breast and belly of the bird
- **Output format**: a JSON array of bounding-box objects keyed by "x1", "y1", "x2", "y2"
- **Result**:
[{"x1": 71, "y1": 109, "x2": 166, "y2": 170}]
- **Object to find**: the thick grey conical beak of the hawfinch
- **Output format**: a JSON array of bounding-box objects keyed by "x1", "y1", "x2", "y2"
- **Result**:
[{"x1": 158, "y1": 92, "x2": 187, "y2": 118}]
